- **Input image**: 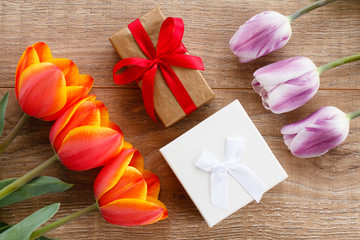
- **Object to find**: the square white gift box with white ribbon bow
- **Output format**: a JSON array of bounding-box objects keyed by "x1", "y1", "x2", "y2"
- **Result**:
[{"x1": 160, "y1": 100, "x2": 287, "y2": 227}]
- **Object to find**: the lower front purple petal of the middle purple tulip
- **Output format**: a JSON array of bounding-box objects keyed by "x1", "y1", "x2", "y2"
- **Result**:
[{"x1": 266, "y1": 71, "x2": 320, "y2": 114}]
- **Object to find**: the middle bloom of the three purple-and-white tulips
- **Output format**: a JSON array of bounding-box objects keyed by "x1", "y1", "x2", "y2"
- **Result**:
[{"x1": 252, "y1": 57, "x2": 320, "y2": 114}]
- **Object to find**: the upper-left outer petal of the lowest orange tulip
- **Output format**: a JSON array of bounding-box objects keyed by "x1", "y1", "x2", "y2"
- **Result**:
[{"x1": 94, "y1": 149, "x2": 134, "y2": 199}]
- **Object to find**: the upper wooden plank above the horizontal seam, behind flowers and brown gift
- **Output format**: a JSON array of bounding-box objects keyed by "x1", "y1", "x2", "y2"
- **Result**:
[{"x1": 0, "y1": 0, "x2": 360, "y2": 89}]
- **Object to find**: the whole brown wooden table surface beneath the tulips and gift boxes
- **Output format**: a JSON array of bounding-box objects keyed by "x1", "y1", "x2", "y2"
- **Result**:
[{"x1": 0, "y1": 0, "x2": 360, "y2": 240}]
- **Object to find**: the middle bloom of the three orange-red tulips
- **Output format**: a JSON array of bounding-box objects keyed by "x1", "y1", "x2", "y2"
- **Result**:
[{"x1": 50, "y1": 96, "x2": 124, "y2": 171}]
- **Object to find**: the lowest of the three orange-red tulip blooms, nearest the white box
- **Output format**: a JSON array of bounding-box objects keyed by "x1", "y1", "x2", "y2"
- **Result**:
[{"x1": 94, "y1": 148, "x2": 168, "y2": 226}]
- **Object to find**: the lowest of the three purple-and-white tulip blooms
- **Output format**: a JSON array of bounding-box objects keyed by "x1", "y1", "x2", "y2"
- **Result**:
[{"x1": 281, "y1": 106, "x2": 351, "y2": 158}]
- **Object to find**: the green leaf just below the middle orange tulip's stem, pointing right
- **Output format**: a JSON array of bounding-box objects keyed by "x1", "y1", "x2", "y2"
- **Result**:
[{"x1": 0, "y1": 176, "x2": 73, "y2": 207}]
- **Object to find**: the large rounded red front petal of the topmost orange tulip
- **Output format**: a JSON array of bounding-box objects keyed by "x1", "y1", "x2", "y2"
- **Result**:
[{"x1": 19, "y1": 63, "x2": 66, "y2": 118}]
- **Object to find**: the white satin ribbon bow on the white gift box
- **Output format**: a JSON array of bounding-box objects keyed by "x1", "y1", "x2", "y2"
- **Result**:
[{"x1": 195, "y1": 137, "x2": 266, "y2": 210}]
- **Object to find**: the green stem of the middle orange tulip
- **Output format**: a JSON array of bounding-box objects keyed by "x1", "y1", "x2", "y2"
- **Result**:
[{"x1": 0, "y1": 154, "x2": 58, "y2": 199}]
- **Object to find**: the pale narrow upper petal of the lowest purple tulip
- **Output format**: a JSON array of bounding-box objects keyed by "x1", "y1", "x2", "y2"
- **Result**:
[{"x1": 281, "y1": 106, "x2": 345, "y2": 134}]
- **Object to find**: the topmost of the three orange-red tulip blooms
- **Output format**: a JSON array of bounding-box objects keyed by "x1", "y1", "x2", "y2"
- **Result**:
[{"x1": 15, "y1": 42, "x2": 93, "y2": 121}]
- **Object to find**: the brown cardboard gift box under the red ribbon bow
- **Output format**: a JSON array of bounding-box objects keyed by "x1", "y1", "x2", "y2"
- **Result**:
[{"x1": 109, "y1": 7, "x2": 215, "y2": 127}]
